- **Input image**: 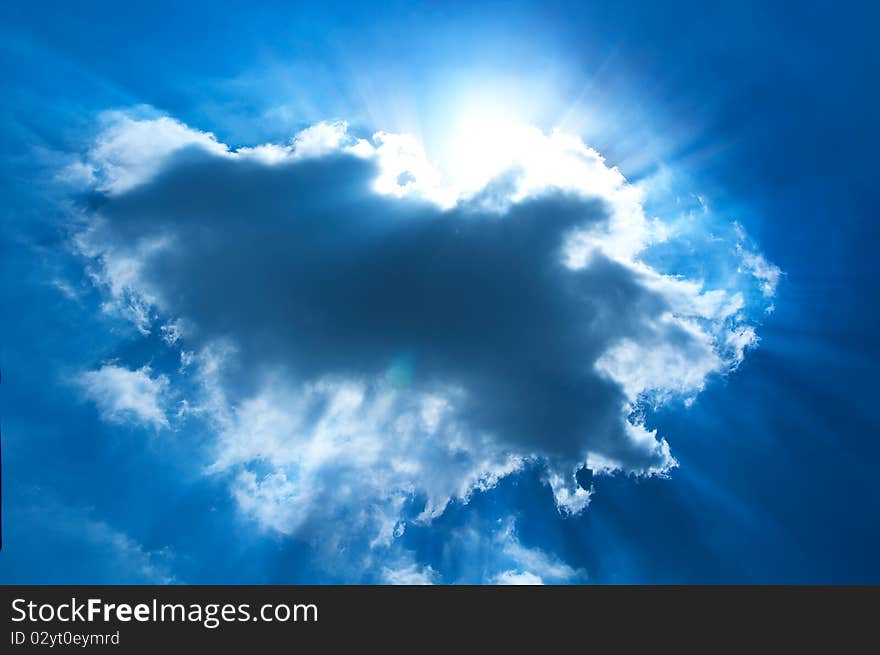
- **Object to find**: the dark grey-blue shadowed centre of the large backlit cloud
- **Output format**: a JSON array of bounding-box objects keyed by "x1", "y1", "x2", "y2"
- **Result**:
[{"x1": 88, "y1": 150, "x2": 692, "y2": 466}]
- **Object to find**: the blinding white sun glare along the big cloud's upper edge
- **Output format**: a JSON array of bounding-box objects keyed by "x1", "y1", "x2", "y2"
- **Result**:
[{"x1": 357, "y1": 103, "x2": 650, "y2": 268}]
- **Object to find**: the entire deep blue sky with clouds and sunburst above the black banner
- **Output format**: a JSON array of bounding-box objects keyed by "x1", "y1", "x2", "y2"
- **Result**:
[{"x1": 0, "y1": 1, "x2": 880, "y2": 584}]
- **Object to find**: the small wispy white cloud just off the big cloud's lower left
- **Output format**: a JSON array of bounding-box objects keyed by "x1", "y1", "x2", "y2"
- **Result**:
[{"x1": 77, "y1": 364, "x2": 169, "y2": 429}]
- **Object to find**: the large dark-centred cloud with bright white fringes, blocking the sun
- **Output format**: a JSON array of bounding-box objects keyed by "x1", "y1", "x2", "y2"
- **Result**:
[{"x1": 69, "y1": 114, "x2": 775, "y2": 568}]
